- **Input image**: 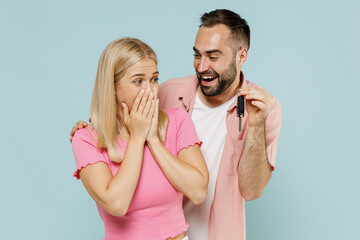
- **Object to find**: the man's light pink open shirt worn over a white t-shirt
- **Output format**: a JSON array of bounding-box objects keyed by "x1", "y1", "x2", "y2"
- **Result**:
[{"x1": 159, "y1": 73, "x2": 282, "y2": 240}]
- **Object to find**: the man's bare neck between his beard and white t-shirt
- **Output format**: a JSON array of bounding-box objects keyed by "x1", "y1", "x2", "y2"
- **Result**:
[{"x1": 197, "y1": 77, "x2": 240, "y2": 108}]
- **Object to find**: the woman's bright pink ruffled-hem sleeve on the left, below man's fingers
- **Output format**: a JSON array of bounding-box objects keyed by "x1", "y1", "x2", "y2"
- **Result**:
[{"x1": 72, "y1": 128, "x2": 107, "y2": 179}]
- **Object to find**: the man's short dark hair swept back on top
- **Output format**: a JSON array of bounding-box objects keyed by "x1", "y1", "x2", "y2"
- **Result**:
[{"x1": 200, "y1": 9, "x2": 250, "y2": 51}]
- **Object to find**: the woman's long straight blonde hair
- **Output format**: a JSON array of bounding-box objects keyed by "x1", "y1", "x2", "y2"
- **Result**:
[{"x1": 91, "y1": 37, "x2": 168, "y2": 162}]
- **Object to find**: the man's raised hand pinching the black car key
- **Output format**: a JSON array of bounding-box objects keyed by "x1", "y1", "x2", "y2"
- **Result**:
[{"x1": 239, "y1": 87, "x2": 272, "y2": 127}]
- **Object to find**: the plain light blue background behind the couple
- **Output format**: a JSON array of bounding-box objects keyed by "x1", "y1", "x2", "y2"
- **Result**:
[{"x1": 0, "y1": 0, "x2": 360, "y2": 240}]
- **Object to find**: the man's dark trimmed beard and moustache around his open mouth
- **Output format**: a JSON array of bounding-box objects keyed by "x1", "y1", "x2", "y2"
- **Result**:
[{"x1": 196, "y1": 57, "x2": 236, "y2": 97}]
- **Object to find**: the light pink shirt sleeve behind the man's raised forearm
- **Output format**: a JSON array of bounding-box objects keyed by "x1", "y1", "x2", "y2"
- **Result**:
[{"x1": 265, "y1": 96, "x2": 282, "y2": 171}]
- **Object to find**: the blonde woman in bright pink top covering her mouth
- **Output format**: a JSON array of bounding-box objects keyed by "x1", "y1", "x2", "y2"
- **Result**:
[{"x1": 72, "y1": 38, "x2": 209, "y2": 240}]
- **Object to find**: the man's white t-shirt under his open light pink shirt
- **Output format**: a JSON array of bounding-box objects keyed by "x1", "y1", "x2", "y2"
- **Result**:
[{"x1": 184, "y1": 93, "x2": 236, "y2": 240}]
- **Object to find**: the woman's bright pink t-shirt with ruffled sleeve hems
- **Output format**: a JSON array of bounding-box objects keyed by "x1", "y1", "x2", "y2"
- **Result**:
[{"x1": 72, "y1": 108, "x2": 201, "y2": 240}]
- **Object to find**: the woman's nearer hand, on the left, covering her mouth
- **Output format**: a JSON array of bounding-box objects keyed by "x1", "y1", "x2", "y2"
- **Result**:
[{"x1": 122, "y1": 90, "x2": 156, "y2": 141}]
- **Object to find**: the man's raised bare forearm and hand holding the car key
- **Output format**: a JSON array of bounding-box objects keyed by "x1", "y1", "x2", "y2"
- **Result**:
[{"x1": 238, "y1": 87, "x2": 273, "y2": 201}]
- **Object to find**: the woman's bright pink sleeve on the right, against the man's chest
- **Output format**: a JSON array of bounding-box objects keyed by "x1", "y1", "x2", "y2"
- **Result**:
[{"x1": 174, "y1": 108, "x2": 202, "y2": 154}]
